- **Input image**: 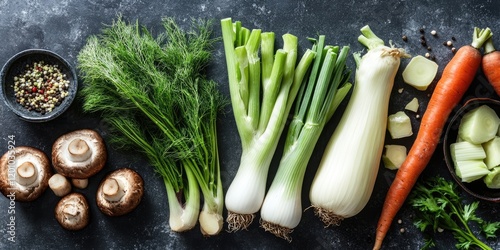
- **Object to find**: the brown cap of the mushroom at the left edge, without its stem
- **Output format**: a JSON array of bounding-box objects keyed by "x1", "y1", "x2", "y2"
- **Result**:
[{"x1": 0, "y1": 146, "x2": 52, "y2": 201}]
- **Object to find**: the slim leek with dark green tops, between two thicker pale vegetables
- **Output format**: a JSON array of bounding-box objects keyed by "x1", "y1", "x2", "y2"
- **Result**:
[{"x1": 261, "y1": 36, "x2": 351, "y2": 241}]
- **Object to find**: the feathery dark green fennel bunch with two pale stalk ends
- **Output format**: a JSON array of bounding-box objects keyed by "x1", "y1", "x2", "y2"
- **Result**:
[{"x1": 78, "y1": 17, "x2": 226, "y2": 235}]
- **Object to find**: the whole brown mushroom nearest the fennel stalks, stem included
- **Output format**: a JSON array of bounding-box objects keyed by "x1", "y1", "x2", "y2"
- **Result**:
[{"x1": 96, "y1": 168, "x2": 144, "y2": 216}]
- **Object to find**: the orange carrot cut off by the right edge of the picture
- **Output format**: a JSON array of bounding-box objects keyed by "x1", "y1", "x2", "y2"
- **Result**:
[{"x1": 481, "y1": 38, "x2": 500, "y2": 95}]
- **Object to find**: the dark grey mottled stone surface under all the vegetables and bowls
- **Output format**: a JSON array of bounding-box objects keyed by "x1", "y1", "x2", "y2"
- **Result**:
[{"x1": 0, "y1": 0, "x2": 500, "y2": 249}]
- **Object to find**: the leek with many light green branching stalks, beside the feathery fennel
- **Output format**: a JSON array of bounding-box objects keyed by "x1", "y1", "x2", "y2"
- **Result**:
[{"x1": 221, "y1": 18, "x2": 314, "y2": 231}]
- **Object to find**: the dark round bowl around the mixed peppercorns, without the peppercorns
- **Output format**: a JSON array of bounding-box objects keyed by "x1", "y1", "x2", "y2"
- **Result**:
[{"x1": 0, "y1": 49, "x2": 78, "y2": 122}]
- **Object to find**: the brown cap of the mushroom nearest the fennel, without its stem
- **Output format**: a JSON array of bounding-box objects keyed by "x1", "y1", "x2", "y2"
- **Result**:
[{"x1": 96, "y1": 168, "x2": 144, "y2": 216}]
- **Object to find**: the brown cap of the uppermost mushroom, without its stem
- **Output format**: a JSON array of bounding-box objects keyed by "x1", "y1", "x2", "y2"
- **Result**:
[{"x1": 52, "y1": 129, "x2": 107, "y2": 179}]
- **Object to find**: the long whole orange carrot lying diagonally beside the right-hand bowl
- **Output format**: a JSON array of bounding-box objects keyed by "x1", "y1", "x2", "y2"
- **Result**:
[{"x1": 373, "y1": 28, "x2": 491, "y2": 249}]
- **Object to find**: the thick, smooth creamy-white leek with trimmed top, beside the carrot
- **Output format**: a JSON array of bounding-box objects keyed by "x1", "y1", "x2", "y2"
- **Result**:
[{"x1": 309, "y1": 26, "x2": 406, "y2": 226}]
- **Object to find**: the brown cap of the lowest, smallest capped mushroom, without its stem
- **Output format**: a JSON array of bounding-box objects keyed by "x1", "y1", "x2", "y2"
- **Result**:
[{"x1": 54, "y1": 193, "x2": 90, "y2": 231}]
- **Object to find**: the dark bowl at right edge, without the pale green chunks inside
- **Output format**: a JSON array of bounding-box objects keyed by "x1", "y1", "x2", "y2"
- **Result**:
[{"x1": 443, "y1": 98, "x2": 500, "y2": 202}]
